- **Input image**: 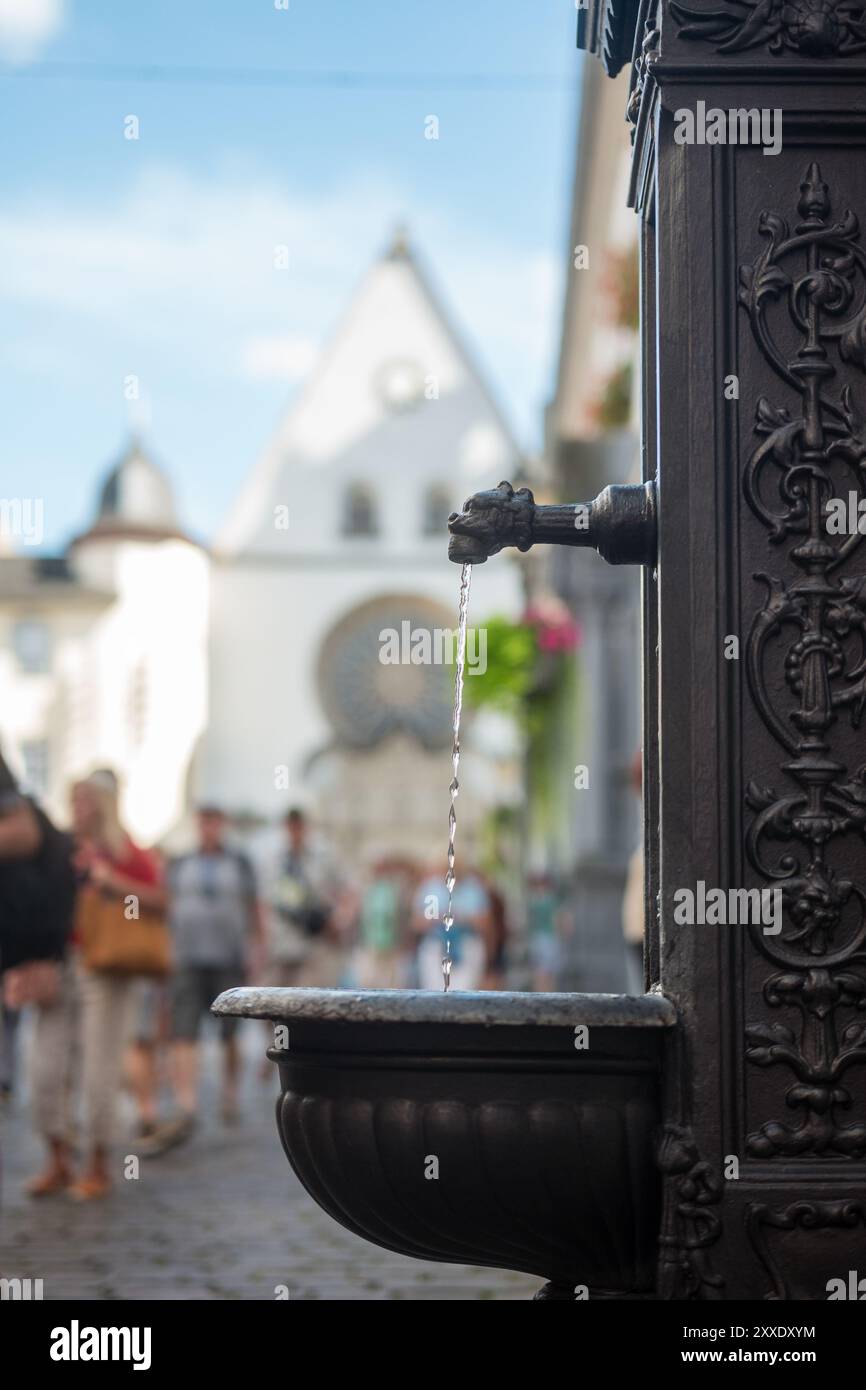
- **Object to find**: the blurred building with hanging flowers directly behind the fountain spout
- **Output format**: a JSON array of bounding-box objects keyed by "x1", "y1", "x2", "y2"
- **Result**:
[{"x1": 530, "y1": 60, "x2": 641, "y2": 991}]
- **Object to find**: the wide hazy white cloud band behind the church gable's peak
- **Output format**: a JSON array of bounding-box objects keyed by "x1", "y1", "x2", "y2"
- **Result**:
[{"x1": 0, "y1": 162, "x2": 560, "y2": 444}]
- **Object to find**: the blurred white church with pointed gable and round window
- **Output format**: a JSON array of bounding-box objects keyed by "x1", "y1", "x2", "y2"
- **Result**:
[{"x1": 207, "y1": 234, "x2": 521, "y2": 858}]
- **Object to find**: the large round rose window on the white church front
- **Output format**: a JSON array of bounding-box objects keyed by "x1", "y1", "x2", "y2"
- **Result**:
[{"x1": 318, "y1": 596, "x2": 453, "y2": 749}]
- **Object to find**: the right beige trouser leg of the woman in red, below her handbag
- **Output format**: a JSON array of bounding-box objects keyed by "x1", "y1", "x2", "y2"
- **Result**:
[{"x1": 81, "y1": 970, "x2": 139, "y2": 1148}]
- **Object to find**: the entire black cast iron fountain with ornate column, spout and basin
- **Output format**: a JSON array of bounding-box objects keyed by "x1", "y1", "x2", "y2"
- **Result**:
[{"x1": 215, "y1": 0, "x2": 866, "y2": 1300}]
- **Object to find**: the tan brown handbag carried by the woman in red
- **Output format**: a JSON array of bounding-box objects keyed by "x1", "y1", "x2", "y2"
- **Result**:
[{"x1": 75, "y1": 884, "x2": 171, "y2": 977}]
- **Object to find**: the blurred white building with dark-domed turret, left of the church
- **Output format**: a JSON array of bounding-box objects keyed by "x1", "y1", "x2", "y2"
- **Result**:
[{"x1": 0, "y1": 441, "x2": 210, "y2": 842}]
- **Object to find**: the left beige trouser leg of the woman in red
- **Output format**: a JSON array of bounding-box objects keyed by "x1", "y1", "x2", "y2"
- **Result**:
[{"x1": 29, "y1": 960, "x2": 81, "y2": 1143}]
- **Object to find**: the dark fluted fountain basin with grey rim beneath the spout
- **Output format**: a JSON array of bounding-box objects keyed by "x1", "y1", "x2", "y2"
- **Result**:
[{"x1": 213, "y1": 988, "x2": 676, "y2": 1295}]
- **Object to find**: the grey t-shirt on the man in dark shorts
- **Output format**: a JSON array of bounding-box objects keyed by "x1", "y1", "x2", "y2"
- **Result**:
[{"x1": 168, "y1": 849, "x2": 256, "y2": 966}]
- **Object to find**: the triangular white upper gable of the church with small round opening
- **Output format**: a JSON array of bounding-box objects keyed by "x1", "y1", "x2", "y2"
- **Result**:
[{"x1": 217, "y1": 236, "x2": 517, "y2": 559}]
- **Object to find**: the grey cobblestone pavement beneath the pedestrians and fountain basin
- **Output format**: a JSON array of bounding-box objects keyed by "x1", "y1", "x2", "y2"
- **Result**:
[{"x1": 0, "y1": 1024, "x2": 542, "y2": 1301}]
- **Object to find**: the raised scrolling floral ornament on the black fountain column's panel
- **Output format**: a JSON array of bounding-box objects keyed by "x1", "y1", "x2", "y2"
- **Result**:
[{"x1": 738, "y1": 164, "x2": 866, "y2": 1158}]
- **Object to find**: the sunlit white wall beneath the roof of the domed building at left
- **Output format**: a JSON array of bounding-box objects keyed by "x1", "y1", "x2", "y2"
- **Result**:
[{"x1": 0, "y1": 539, "x2": 209, "y2": 844}]
